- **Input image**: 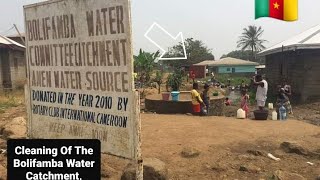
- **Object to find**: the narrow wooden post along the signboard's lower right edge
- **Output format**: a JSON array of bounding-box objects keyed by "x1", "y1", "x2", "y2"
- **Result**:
[{"x1": 135, "y1": 91, "x2": 143, "y2": 180}]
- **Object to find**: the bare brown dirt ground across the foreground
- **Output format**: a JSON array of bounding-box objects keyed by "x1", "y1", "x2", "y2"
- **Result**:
[{"x1": 0, "y1": 102, "x2": 320, "y2": 180}]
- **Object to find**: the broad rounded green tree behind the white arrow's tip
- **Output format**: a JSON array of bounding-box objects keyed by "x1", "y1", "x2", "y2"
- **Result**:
[{"x1": 165, "y1": 38, "x2": 214, "y2": 67}]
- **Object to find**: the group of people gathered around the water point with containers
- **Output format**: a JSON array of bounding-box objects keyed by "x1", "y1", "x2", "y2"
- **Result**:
[{"x1": 191, "y1": 75, "x2": 293, "y2": 117}]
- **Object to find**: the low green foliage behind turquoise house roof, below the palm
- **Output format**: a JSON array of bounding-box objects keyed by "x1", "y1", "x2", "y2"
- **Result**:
[{"x1": 221, "y1": 50, "x2": 265, "y2": 64}]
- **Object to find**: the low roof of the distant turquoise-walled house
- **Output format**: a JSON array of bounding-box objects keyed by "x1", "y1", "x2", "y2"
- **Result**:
[{"x1": 194, "y1": 57, "x2": 259, "y2": 66}]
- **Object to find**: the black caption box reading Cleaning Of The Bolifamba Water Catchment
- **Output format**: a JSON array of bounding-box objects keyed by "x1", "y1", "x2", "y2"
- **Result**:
[{"x1": 7, "y1": 139, "x2": 101, "y2": 180}]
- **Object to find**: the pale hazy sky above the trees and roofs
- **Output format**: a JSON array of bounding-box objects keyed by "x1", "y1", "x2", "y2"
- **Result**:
[{"x1": 0, "y1": 0, "x2": 320, "y2": 59}]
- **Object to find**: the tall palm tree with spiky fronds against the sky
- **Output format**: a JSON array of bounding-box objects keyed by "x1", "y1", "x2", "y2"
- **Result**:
[{"x1": 237, "y1": 26, "x2": 267, "y2": 59}]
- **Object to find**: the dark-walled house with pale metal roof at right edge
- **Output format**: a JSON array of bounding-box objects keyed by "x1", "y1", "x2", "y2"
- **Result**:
[{"x1": 259, "y1": 25, "x2": 320, "y2": 102}]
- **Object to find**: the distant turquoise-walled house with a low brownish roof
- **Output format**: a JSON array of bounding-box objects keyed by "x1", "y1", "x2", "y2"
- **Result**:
[{"x1": 195, "y1": 57, "x2": 259, "y2": 75}]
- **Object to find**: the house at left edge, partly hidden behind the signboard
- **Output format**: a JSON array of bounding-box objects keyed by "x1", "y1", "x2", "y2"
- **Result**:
[{"x1": 0, "y1": 35, "x2": 26, "y2": 91}]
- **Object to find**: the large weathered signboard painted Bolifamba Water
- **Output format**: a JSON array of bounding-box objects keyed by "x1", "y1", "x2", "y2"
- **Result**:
[{"x1": 24, "y1": 0, "x2": 139, "y2": 159}]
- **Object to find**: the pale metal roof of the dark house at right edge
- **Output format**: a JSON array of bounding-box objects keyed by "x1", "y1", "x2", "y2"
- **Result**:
[{"x1": 259, "y1": 24, "x2": 320, "y2": 56}]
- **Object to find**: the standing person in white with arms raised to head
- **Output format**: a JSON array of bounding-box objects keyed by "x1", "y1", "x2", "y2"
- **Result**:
[{"x1": 253, "y1": 74, "x2": 268, "y2": 111}]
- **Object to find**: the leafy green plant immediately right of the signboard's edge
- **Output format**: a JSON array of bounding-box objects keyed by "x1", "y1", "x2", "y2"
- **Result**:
[{"x1": 134, "y1": 49, "x2": 160, "y2": 83}]
